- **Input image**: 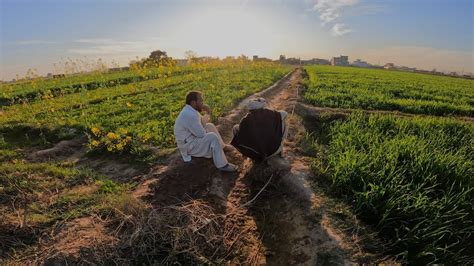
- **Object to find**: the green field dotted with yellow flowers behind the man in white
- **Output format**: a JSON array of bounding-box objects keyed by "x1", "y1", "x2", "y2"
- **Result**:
[{"x1": 0, "y1": 63, "x2": 289, "y2": 152}]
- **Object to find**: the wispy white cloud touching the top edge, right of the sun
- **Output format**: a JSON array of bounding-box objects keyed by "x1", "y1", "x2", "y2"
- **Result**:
[{"x1": 313, "y1": 0, "x2": 359, "y2": 25}]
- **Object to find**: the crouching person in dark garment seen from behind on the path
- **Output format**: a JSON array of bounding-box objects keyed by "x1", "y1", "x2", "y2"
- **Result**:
[{"x1": 231, "y1": 98, "x2": 287, "y2": 162}]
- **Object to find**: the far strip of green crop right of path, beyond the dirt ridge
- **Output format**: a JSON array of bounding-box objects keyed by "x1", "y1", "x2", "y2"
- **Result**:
[{"x1": 304, "y1": 66, "x2": 474, "y2": 117}]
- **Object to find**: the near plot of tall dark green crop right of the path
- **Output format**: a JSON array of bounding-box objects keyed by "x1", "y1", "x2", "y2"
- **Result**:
[{"x1": 315, "y1": 112, "x2": 474, "y2": 264}]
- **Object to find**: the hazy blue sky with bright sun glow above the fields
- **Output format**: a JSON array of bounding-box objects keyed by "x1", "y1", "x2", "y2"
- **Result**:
[{"x1": 0, "y1": 0, "x2": 474, "y2": 80}]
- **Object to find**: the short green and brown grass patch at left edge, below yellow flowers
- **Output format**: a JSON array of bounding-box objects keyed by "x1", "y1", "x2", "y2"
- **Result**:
[{"x1": 0, "y1": 160, "x2": 130, "y2": 254}]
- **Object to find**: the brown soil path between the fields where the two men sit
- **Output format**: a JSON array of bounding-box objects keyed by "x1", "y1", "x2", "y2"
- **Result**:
[{"x1": 134, "y1": 68, "x2": 370, "y2": 265}]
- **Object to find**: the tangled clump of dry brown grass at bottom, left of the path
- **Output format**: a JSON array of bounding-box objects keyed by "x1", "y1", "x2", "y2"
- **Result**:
[{"x1": 107, "y1": 197, "x2": 246, "y2": 264}]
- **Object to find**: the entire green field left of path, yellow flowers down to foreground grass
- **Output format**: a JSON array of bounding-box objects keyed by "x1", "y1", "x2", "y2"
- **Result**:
[{"x1": 0, "y1": 62, "x2": 292, "y2": 256}]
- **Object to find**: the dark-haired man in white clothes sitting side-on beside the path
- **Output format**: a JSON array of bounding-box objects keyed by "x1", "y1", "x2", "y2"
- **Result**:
[{"x1": 174, "y1": 91, "x2": 237, "y2": 172}]
